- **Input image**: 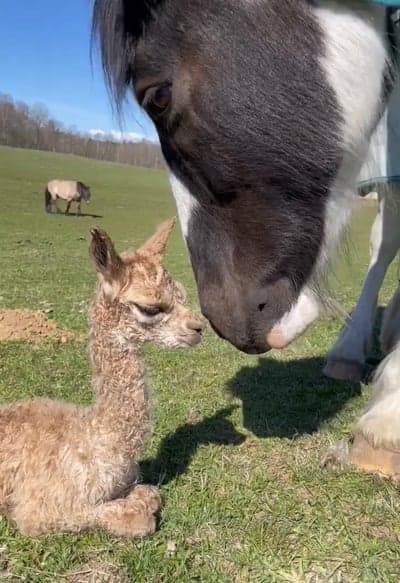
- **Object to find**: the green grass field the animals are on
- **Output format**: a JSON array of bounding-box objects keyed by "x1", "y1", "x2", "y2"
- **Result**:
[{"x1": 0, "y1": 148, "x2": 400, "y2": 583}]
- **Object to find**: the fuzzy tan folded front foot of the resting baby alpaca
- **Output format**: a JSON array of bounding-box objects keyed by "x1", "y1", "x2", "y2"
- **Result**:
[{"x1": 98, "y1": 486, "x2": 161, "y2": 537}]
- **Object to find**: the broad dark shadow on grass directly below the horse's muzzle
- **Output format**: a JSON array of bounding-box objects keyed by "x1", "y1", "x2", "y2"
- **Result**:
[{"x1": 228, "y1": 358, "x2": 361, "y2": 438}]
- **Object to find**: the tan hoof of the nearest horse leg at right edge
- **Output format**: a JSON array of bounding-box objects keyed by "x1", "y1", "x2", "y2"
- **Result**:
[{"x1": 349, "y1": 433, "x2": 400, "y2": 480}]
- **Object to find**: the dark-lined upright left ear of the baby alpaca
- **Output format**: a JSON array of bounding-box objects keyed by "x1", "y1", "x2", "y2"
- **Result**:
[{"x1": 89, "y1": 229, "x2": 123, "y2": 282}]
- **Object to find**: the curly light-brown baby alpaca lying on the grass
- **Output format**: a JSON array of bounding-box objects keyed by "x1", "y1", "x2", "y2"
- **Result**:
[{"x1": 0, "y1": 221, "x2": 202, "y2": 537}]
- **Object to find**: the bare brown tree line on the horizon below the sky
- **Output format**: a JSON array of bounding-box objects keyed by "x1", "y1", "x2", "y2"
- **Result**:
[{"x1": 0, "y1": 93, "x2": 164, "y2": 168}]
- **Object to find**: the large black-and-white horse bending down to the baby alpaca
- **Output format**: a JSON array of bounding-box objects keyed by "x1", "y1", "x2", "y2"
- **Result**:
[{"x1": 93, "y1": 0, "x2": 400, "y2": 475}]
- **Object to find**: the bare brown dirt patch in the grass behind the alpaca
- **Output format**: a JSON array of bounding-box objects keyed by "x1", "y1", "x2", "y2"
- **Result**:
[{"x1": 0, "y1": 310, "x2": 74, "y2": 342}]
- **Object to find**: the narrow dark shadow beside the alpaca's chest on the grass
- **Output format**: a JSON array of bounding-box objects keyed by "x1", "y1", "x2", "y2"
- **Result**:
[{"x1": 140, "y1": 407, "x2": 245, "y2": 484}]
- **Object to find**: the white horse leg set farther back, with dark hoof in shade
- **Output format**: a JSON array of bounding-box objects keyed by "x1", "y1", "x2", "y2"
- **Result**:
[{"x1": 324, "y1": 186, "x2": 400, "y2": 381}]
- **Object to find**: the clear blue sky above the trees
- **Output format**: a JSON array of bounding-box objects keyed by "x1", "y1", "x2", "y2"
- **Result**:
[{"x1": 0, "y1": 0, "x2": 156, "y2": 140}]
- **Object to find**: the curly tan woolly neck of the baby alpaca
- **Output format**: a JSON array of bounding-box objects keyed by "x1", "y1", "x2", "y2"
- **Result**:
[{"x1": 89, "y1": 303, "x2": 149, "y2": 457}]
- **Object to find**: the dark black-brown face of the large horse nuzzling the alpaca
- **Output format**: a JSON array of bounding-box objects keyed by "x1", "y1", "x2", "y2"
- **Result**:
[{"x1": 94, "y1": 0, "x2": 384, "y2": 352}]
